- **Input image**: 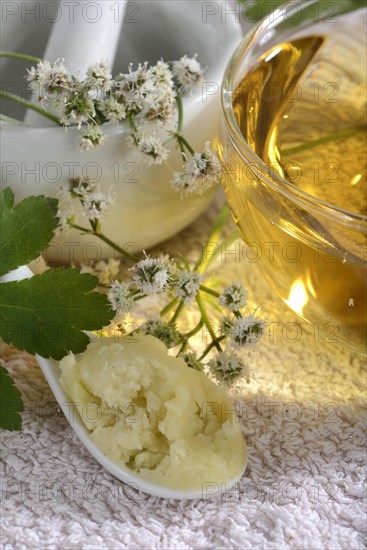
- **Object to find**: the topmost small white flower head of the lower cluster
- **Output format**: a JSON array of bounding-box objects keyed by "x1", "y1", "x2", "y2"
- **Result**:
[{"x1": 132, "y1": 256, "x2": 170, "y2": 296}]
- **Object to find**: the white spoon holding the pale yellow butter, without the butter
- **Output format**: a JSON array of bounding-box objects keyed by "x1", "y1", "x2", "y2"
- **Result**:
[{"x1": 0, "y1": 266, "x2": 246, "y2": 500}]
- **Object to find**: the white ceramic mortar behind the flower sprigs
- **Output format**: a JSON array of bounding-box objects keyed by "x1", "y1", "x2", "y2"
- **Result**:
[{"x1": 0, "y1": 0, "x2": 246, "y2": 264}]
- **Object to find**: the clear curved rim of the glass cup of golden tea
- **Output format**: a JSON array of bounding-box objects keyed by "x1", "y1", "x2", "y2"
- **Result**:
[{"x1": 221, "y1": 0, "x2": 367, "y2": 232}]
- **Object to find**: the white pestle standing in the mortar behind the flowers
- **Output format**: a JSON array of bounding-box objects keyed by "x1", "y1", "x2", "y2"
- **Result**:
[{"x1": 24, "y1": 0, "x2": 125, "y2": 126}]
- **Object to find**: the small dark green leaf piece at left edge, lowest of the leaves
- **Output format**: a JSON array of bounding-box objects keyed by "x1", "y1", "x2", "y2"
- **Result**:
[{"x1": 0, "y1": 366, "x2": 24, "y2": 430}]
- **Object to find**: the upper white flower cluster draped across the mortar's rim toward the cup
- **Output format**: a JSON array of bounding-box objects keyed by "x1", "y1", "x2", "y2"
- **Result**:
[{"x1": 27, "y1": 55, "x2": 220, "y2": 199}]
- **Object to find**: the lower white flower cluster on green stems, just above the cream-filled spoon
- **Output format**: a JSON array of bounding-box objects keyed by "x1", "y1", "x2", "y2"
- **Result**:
[{"x1": 102, "y1": 250, "x2": 267, "y2": 385}]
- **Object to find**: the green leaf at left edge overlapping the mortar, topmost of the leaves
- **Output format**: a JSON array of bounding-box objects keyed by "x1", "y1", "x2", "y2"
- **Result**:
[{"x1": 0, "y1": 188, "x2": 58, "y2": 275}]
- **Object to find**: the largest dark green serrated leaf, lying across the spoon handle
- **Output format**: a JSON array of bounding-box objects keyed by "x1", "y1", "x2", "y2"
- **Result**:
[{"x1": 0, "y1": 268, "x2": 114, "y2": 360}]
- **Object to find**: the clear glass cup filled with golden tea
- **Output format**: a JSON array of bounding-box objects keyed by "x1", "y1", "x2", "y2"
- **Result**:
[{"x1": 220, "y1": 0, "x2": 367, "y2": 350}]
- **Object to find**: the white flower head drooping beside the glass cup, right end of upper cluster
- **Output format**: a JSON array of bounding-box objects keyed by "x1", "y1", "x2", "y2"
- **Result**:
[{"x1": 171, "y1": 141, "x2": 221, "y2": 196}]
